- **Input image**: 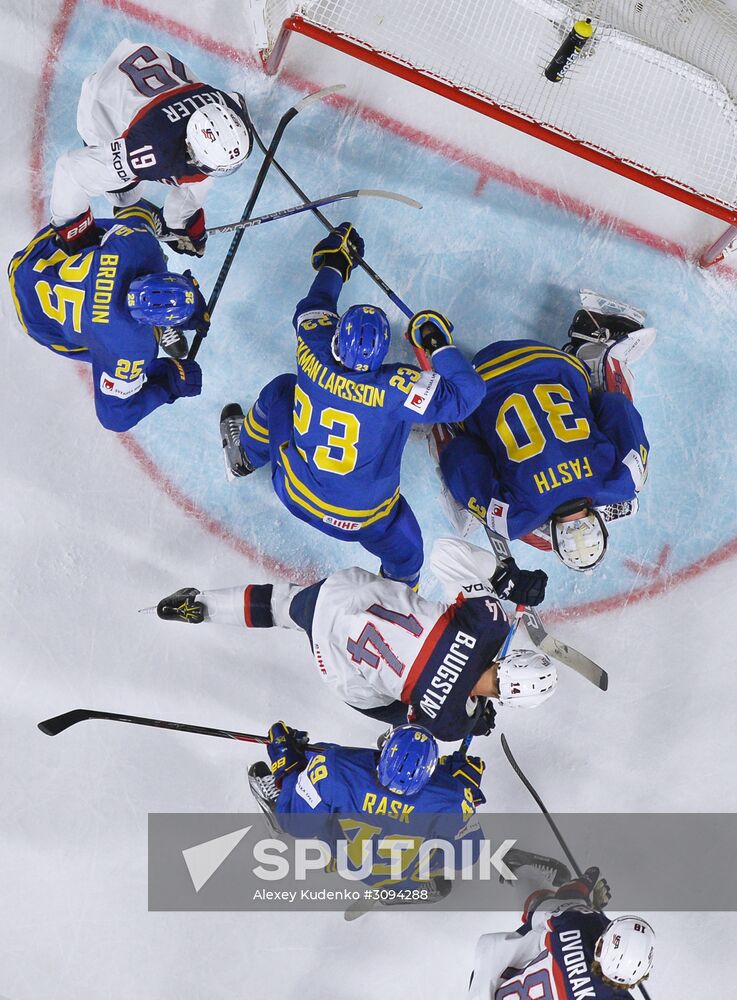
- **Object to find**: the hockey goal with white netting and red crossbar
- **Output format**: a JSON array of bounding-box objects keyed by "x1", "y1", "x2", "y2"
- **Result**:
[{"x1": 251, "y1": 0, "x2": 737, "y2": 250}]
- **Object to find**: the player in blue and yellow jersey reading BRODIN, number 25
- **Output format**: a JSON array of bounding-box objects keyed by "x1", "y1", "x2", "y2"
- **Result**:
[{"x1": 8, "y1": 202, "x2": 209, "y2": 431}]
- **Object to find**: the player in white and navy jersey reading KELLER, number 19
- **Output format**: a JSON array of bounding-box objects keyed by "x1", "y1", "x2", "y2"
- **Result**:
[{"x1": 51, "y1": 38, "x2": 253, "y2": 256}]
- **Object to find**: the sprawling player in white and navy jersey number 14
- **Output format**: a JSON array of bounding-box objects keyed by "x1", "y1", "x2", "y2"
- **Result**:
[{"x1": 157, "y1": 538, "x2": 557, "y2": 741}]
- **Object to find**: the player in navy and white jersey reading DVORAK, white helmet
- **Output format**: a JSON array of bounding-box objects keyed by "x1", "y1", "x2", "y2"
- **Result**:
[{"x1": 467, "y1": 868, "x2": 655, "y2": 1000}]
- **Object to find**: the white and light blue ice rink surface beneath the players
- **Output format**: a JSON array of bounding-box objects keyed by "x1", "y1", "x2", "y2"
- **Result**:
[{"x1": 0, "y1": 0, "x2": 737, "y2": 1000}]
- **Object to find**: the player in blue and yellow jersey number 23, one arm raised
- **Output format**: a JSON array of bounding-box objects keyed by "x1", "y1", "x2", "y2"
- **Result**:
[{"x1": 220, "y1": 222, "x2": 484, "y2": 587}]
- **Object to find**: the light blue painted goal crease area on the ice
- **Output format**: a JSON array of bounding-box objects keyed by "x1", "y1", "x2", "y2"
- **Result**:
[{"x1": 44, "y1": 0, "x2": 737, "y2": 618}]
